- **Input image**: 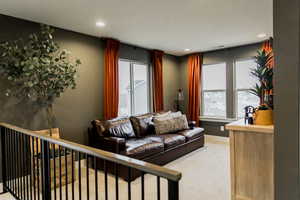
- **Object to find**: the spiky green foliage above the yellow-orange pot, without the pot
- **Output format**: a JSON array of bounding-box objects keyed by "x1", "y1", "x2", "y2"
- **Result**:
[{"x1": 250, "y1": 50, "x2": 273, "y2": 108}]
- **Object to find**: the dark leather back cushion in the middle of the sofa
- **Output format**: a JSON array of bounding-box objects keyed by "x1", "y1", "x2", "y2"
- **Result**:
[{"x1": 130, "y1": 113, "x2": 155, "y2": 137}]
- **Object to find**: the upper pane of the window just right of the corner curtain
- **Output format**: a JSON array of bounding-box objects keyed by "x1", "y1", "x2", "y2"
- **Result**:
[{"x1": 202, "y1": 63, "x2": 226, "y2": 90}]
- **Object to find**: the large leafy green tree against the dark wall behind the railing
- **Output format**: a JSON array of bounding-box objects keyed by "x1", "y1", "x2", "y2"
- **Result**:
[{"x1": 0, "y1": 25, "x2": 81, "y2": 135}]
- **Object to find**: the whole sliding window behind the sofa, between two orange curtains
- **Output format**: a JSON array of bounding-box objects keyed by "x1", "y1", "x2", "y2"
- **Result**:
[{"x1": 119, "y1": 60, "x2": 150, "y2": 116}]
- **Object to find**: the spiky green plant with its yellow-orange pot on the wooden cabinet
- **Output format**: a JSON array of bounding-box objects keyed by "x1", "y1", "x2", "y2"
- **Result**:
[{"x1": 250, "y1": 50, "x2": 273, "y2": 125}]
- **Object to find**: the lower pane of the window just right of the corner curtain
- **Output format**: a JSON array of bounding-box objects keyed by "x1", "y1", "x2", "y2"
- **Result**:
[{"x1": 203, "y1": 91, "x2": 226, "y2": 118}]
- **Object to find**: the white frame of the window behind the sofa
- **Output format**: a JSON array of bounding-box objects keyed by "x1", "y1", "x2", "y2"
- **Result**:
[{"x1": 118, "y1": 58, "x2": 151, "y2": 117}]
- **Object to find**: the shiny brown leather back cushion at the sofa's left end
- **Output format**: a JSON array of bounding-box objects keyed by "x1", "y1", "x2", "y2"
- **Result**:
[{"x1": 104, "y1": 118, "x2": 135, "y2": 138}]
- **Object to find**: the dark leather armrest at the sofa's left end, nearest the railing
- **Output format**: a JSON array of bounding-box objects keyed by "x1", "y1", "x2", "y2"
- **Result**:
[{"x1": 94, "y1": 137, "x2": 126, "y2": 153}]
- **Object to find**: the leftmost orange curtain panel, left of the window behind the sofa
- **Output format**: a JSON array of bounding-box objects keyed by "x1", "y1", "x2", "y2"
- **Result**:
[{"x1": 104, "y1": 39, "x2": 120, "y2": 120}]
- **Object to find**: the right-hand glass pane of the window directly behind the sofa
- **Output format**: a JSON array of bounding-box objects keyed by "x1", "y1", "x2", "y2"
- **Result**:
[{"x1": 133, "y1": 64, "x2": 149, "y2": 114}]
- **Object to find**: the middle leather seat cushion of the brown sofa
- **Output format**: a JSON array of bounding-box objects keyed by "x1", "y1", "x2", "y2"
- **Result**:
[{"x1": 147, "y1": 134, "x2": 186, "y2": 149}]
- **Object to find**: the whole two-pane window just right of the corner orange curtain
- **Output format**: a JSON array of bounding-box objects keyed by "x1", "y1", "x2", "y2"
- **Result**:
[{"x1": 202, "y1": 63, "x2": 226, "y2": 118}]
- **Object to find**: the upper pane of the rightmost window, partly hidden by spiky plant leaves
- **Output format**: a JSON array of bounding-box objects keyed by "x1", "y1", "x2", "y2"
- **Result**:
[{"x1": 235, "y1": 59, "x2": 257, "y2": 89}]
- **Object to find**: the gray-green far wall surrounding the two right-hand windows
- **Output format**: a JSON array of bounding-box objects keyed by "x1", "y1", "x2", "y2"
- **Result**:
[{"x1": 180, "y1": 43, "x2": 262, "y2": 136}]
